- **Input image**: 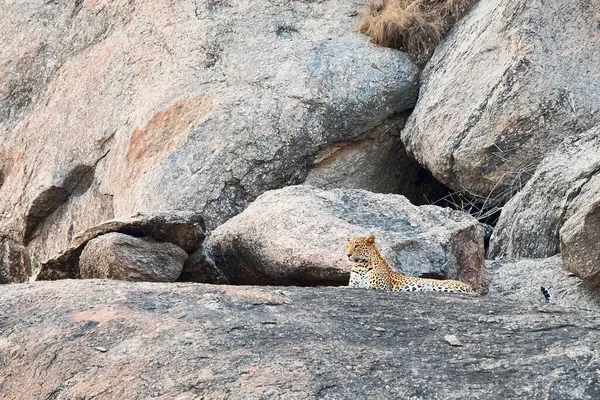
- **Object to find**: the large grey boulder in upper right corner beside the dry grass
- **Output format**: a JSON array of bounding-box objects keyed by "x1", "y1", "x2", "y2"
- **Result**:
[{"x1": 402, "y1": 0, "x2": 600, "y2": 202}]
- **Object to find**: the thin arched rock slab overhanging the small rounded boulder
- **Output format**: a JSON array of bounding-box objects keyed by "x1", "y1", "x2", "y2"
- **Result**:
[{"x1": 36, "y1": 212, "x2": 204, "y2": 280}]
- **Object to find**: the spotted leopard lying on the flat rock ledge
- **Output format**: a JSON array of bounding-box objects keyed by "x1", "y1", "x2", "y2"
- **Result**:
[{"x1": 346, "y1": 235, "x2": 477, "y2": 294}]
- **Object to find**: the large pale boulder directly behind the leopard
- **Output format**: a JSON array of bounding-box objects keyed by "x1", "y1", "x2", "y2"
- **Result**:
[{"x1": 206, "y1": 186, "x2": 487, "y2": 291}]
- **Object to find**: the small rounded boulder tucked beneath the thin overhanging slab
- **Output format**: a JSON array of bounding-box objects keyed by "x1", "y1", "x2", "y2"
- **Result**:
[{"x1": 79, "y1": 232, "x2": 188, "y2": 282}]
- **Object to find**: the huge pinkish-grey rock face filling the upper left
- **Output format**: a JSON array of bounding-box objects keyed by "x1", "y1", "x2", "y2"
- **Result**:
[{"x1": 0, "y1": 0, "x2": 419, "y2": 284}]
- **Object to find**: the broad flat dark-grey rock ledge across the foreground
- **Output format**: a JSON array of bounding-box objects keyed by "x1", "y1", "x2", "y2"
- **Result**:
[{"x1": 0, "y1": 280, "x2": 600, "y2": 399}]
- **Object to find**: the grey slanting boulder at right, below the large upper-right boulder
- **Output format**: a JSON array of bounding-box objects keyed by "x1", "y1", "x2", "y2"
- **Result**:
[{"x1": 489, "y1": 125, "x2": 600, "y2": 258}]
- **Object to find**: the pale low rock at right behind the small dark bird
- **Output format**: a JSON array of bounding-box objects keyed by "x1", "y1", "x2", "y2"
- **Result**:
[{"x1": 486, "y1": 255, "x2": 600, "y2": 312}]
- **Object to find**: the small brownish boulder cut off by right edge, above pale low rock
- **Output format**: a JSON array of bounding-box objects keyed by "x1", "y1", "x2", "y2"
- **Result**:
[{"x1": 560, "y1": 198, "x2": 600, "y2": 287}]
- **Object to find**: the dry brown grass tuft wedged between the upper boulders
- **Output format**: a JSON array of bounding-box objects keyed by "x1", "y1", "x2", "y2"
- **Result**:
[{"x1": 358, "y1": 0, "x2": 477, "y2": 62}]
